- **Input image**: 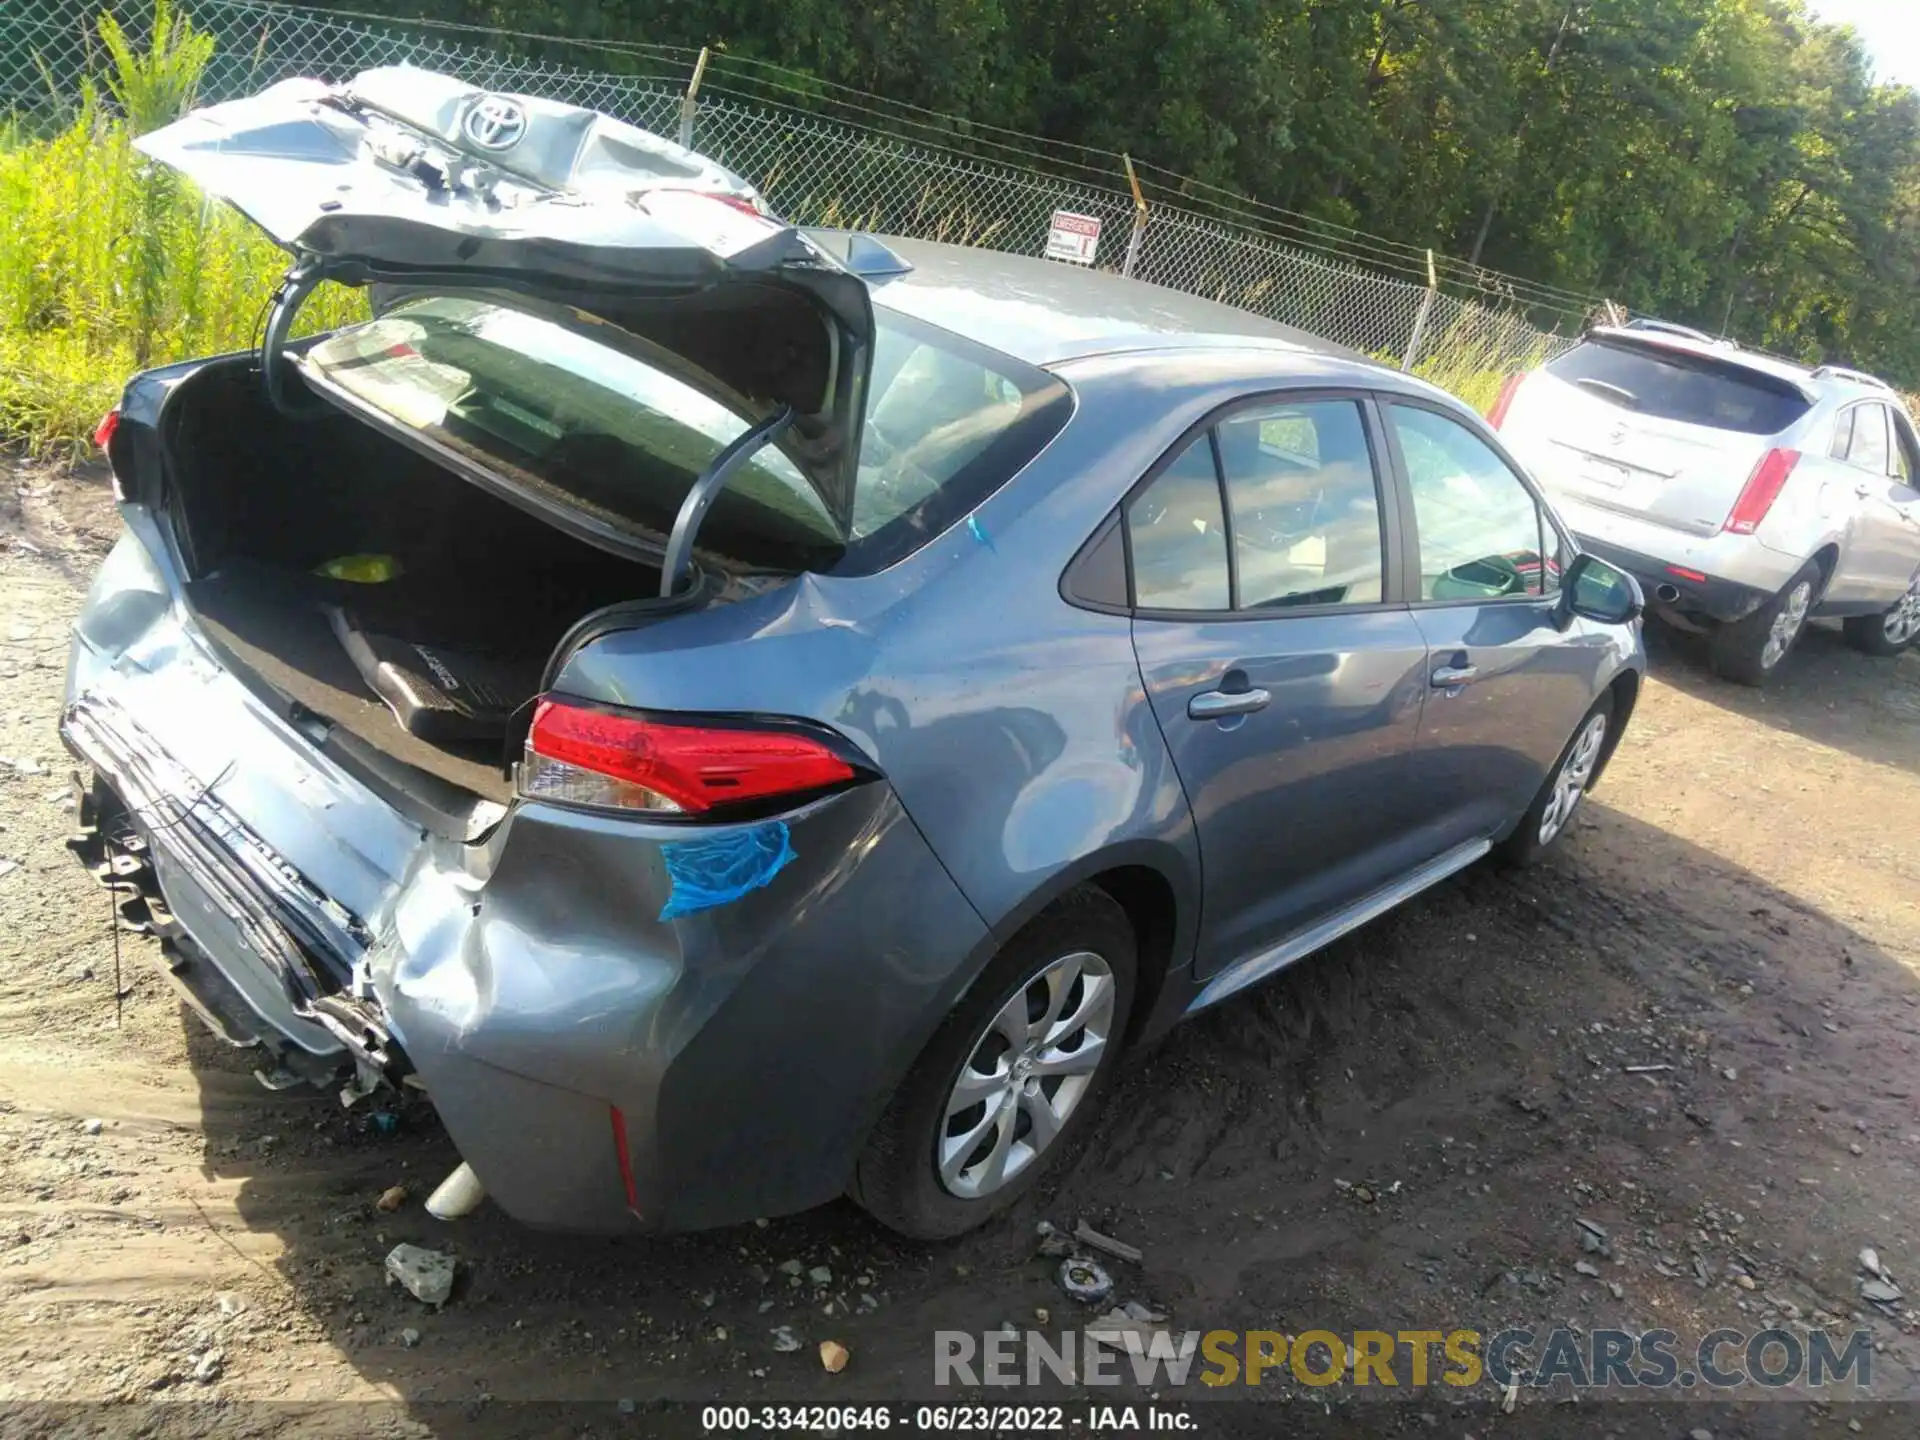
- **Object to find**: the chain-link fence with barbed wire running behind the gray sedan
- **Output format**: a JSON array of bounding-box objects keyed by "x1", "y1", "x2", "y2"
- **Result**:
[{"x1": 0, "y1": 0, "x2": 1597, "y2": 395}]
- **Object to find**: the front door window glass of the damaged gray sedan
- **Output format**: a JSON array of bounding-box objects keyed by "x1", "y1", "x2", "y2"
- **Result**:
[{"x1": 1388, "y1": 405, "x2": 1557, "y2": 601}]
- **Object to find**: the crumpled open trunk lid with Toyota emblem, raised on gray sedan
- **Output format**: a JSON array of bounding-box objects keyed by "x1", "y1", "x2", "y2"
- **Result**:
[{"x1": 138, "y1": 67, "x2": 874, "y2": 534}]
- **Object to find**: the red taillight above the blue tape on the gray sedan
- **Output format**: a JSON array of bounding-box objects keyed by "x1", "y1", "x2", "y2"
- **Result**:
[{"x1": 520, "y1": 697, "x2": 858, "y2": 814}]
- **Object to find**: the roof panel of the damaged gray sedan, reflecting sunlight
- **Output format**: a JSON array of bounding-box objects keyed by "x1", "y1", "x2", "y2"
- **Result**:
[{"x1": 848, "y1": 236, "x2": 1365, "y2": 367}]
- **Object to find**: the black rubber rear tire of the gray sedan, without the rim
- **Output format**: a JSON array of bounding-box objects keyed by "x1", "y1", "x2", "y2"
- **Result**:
[{"x1": 849, "y1": 885, "x2": 1139, "y2": 1240}]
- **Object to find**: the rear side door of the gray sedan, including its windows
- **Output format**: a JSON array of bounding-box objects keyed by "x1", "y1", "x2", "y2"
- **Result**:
[{"x1": 1123, "y1": 394, "x2": 1427, "y2": 975}]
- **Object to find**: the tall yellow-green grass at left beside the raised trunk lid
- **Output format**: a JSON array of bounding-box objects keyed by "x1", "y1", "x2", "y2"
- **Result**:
[{"x1": 0, "y1": 0, "x2": 365, "y2": 457}]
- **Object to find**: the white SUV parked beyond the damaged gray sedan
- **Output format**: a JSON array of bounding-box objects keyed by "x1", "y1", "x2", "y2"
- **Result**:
[{"x1": 1488, "y1": 328, "x2": 1920, "y2": 685}]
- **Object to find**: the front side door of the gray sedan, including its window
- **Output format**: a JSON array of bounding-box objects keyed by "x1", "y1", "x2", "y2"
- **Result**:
[{"x1": 1382, "y1": 399, "x2": 1607, "y2": 849}]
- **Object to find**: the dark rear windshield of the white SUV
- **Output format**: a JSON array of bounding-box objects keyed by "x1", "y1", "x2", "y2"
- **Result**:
[{"x1": 1548, "y1": 340, "x2": 1809, "y2": 436}]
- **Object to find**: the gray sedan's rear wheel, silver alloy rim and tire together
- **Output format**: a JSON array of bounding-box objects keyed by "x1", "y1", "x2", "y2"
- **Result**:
[{"x1": 852, "y1": 887, "x2": 1135, "y2": 1240}]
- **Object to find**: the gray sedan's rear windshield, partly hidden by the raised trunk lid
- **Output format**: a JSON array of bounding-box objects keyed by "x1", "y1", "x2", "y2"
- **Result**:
[{"x1": 305, "y1": 296, "x2": 1068, "y2": 572}]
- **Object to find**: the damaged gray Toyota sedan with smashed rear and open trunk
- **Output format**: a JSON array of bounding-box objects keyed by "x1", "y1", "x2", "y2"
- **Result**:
[{"x1": 63, "y1": 71, "x2": 1644, "y2": 1236}]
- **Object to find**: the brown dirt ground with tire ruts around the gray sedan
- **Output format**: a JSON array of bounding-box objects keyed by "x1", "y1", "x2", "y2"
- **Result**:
[{"x1": 0, "y1": 461, "x2": 1920, "y2": 1440}]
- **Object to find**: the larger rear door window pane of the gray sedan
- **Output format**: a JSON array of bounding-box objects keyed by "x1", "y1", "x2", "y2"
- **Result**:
[{"x1": 1217, "y1": 399, "x2": 1382, "y2": 611}]
